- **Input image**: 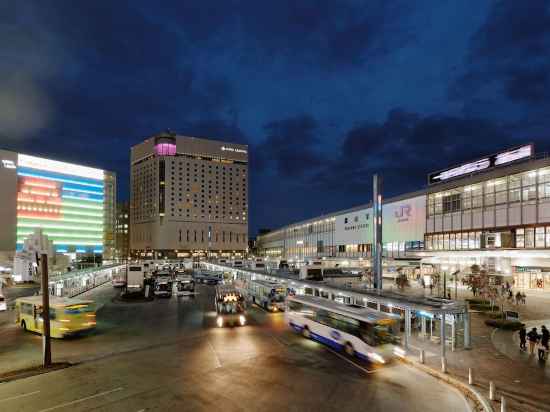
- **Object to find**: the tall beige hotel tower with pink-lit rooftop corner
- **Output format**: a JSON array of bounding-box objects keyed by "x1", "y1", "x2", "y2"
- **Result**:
[{"x1": 130, "y1": 133, "x2": 248, "y2": 258}]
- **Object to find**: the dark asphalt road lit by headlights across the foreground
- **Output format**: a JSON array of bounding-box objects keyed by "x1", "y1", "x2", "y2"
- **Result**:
[{"x1": 0, "y1": 286, "x2": 468, "y2": 412}]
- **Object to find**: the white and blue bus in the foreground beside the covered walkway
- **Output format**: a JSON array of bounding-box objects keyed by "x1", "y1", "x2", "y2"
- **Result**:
[{"x1": 285, "y1": 295, "x2": 405, "y2": 364}]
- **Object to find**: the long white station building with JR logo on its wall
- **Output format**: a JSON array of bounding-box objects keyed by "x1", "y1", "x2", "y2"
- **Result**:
[{"x1": 257, "y1": 144, "x2": 550, "y2": 290}]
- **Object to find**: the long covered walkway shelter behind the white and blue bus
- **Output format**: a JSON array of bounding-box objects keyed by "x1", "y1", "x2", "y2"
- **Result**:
[{"x1": 205, "y1": 262, "x2": 471, "y2": 365}]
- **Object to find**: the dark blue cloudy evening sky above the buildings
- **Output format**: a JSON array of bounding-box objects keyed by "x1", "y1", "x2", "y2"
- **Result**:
[{"x1": 0, "y1": 0, "x2": 550, "y2": 235}]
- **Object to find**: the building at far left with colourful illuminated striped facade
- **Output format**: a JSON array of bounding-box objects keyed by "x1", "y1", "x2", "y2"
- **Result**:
[{"x1": 0, "y1": 150, "x2": 116, "y2": 262}]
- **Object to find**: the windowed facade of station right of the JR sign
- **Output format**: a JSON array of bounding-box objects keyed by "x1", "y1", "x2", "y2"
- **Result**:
[{"x1": 425, "y1": 167, "x2": 550, "y2": 250}]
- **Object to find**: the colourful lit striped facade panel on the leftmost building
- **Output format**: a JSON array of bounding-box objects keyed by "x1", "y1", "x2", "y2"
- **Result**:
[{"x1": 17, "y1": 154, "x2": 104, "y2": 253}]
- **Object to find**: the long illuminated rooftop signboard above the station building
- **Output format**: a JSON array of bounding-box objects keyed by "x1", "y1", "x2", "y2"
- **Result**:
[{"x1": 428, "y1": 144, "x2": 534, "y2": 185}]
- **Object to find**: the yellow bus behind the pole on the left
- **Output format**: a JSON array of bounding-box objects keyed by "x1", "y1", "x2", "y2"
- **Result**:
[{"x1": 15, "y1": 296, "x2": 96, "y2": 338}]
